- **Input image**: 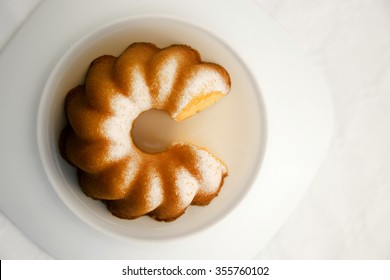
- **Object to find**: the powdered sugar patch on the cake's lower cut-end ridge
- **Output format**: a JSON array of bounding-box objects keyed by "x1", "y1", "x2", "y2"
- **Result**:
[{"x1": 196, "y1": 149, "x2": 227, "y2": 194}]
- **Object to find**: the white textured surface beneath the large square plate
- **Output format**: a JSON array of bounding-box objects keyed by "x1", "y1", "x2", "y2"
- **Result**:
[{"x1": 0, "y1": 0, "x2": 390, "y2": 259}]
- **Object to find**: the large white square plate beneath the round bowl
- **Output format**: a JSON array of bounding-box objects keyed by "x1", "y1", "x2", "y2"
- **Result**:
[{"x1": 0, "y1": 0, "x2": 332, "y2": 259}]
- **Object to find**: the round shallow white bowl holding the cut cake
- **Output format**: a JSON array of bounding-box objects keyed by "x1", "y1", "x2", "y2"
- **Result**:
[{"x1": 38, "y1": 14, "x2": 265, "y2": 240}]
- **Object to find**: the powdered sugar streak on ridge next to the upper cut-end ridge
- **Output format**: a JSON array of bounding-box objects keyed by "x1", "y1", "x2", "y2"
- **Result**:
[{"x1": 157, "y1": 58, "x2": 178, "y2": 103}]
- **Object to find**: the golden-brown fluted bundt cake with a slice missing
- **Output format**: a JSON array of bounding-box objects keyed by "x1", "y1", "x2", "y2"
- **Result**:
[{"x1": 60, "y1": 43, "x2": 230, "y2": 221}]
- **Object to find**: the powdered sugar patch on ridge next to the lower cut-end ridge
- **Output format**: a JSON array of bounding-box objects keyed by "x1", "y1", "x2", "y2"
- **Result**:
[{"x1": 176, "y1": 167, "x2": 199, "y2": 207}]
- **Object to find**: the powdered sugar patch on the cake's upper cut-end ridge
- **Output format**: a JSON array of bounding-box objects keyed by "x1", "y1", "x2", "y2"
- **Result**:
[{"x1": 172, "y1": 68, "x2": 229, "y2": 117}]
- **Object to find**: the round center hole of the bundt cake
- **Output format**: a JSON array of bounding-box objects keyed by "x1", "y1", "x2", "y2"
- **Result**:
[{"x1": 131, "y1": 109, "x2": 178, "y2": 153}]
